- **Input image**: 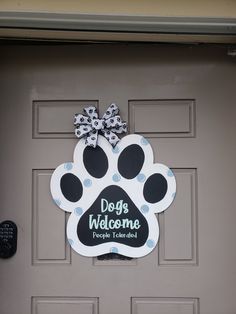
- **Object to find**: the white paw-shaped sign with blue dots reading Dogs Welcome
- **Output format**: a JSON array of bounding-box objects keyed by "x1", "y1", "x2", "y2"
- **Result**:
[{"x1": 51, "y1": 134, "x2": 176, "y2": 257}]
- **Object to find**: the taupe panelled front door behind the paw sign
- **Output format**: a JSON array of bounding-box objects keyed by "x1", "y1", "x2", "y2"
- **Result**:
[{"x1": 0, "y1": 44, "x2": 236, "y2": 314}]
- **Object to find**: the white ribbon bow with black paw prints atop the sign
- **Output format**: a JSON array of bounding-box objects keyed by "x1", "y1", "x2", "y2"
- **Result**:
[{"x1": 74, "y1": 103, "x2": 127, "y2": 147}]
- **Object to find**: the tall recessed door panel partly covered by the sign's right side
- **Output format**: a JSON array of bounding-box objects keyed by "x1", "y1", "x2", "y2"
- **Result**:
[{"x1": 158, "y1": 168, "x2": 198, "y2": 266}]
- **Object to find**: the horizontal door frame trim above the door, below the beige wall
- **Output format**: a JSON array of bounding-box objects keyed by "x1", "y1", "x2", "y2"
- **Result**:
[{"x1": 0, "y1": 12, "x2": 236, "y2": 44}]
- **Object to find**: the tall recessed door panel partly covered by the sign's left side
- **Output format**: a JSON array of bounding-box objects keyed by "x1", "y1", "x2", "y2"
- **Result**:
[{"x1": 32, "y1": 169, "x2": 71, "y2": 264}]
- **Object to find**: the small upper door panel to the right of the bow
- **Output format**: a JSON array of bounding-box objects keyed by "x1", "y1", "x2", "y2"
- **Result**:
[{"x1": 129, "y1": 99, "x2": 196, "y2": 137}]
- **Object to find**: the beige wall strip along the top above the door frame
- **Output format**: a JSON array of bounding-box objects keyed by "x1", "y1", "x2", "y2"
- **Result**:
[{"x1": 0, "y1": 0, "x2": 236, "y2": 18}]
